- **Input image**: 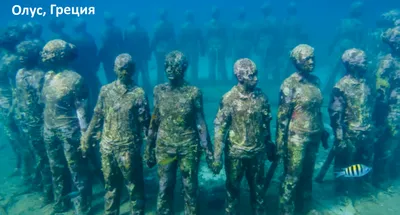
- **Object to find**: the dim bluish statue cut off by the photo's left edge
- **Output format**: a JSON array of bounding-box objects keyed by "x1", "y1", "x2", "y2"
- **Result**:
[{"x1": 0, "y1": 23, "x2": 27, "y2": 180}]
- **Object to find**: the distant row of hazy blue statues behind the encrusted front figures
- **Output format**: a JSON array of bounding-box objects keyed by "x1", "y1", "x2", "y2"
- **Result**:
[{"x1": 40, "y1": 1, "x2": 400, "y2": 124}]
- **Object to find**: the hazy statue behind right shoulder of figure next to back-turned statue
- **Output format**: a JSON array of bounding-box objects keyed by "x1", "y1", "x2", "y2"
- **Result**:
[{"x1": 124, "y1": 13, "x2": 153, "y2": 93}]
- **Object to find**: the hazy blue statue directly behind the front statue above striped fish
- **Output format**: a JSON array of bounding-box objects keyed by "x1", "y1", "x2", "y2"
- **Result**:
[{"x1": 323, "y1": 1, "x2": 366, "y2": 94}]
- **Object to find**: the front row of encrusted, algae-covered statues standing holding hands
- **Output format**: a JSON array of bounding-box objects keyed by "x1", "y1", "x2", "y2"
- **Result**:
[{"x1": 1, "y1": 23, "x2": 400, "y2": 214}]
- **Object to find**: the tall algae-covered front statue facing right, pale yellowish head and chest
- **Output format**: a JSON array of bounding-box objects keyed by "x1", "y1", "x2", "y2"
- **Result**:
[{"x1": 276, "y1": 44, "x2": 328, "y2": 215}]
